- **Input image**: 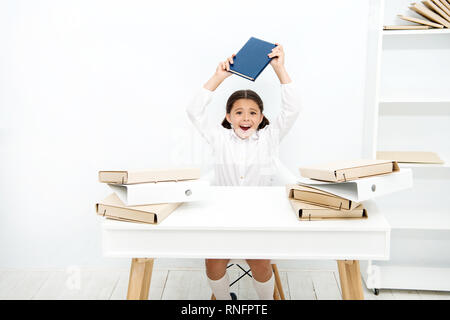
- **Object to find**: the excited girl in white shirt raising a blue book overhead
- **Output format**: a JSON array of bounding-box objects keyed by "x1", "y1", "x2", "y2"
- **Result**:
[{"x1": 187, "y1": 44, "x2": 300, "y2": 300}]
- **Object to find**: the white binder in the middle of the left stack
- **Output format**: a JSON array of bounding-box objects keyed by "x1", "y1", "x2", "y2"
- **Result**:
[{"x1": 108, "y1": 180, "x2": 209, "y2": 206}]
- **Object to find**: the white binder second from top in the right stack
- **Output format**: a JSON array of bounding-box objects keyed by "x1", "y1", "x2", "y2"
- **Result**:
[{"x1": 298, "y1": 168, "x2": 412, "y2": 202}]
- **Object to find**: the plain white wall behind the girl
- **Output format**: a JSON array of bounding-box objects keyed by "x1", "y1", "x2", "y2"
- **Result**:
[{"x1": 0, "y1": 0, "x2": 368, "y2": 267}]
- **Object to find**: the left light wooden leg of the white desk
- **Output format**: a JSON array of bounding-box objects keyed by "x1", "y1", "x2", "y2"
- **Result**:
[{"x1": 127, "y1": 258, "x2": 154, "y2": 300}]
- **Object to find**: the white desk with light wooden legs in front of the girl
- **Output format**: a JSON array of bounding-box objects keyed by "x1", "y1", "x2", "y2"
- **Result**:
[{"x1": 102, "y1": 187, "x2": 390, "y2": 299}]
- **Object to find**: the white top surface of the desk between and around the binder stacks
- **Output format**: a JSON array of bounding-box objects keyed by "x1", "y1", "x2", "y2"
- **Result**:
[{"x1": 102, "y1": 187, "x2": 390, "y2": 231}]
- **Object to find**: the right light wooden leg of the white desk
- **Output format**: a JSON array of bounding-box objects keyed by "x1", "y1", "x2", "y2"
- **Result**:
[{"x1": 337, "y1": 260, "x2": 364, "y2": 300}]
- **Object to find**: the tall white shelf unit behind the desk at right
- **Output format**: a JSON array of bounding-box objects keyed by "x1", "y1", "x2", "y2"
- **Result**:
[{"x1": 361, "y1": 0, "x2": 450, "y2": 291}]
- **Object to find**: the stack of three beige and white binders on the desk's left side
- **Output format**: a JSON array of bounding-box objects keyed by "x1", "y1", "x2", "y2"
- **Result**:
[{"x1": 96, "y1": 168, "x2": 209, "y2": 224}]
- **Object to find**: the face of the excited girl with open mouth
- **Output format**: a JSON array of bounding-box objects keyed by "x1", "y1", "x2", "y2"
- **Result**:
[{"x1": 226, "y1": 99, "x2": 264, "y2": 139}]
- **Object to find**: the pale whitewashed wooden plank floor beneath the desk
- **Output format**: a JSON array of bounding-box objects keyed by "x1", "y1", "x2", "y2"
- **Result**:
[{"x1": 0, "y1": 267, "x2": 450, "y2": 300}]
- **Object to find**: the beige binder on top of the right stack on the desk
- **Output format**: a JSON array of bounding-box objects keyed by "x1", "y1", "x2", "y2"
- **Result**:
[{"x1": 300, "y1": 159, "x2": 400, "y2": 182}]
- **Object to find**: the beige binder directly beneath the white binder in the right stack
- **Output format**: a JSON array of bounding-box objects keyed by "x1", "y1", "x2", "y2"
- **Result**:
[{"x1": 286, "y1": 185, "x2": 359, "y2": 210}]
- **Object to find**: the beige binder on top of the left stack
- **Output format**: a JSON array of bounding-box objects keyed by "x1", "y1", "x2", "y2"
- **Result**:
[{"x1": 98, "y1": 168, "x2": 200, "y2": 184}]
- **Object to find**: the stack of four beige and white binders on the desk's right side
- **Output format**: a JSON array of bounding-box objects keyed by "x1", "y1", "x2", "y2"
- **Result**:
[{"x1": 287, "y1": 160, "x2": 412, "y2": 220}]
